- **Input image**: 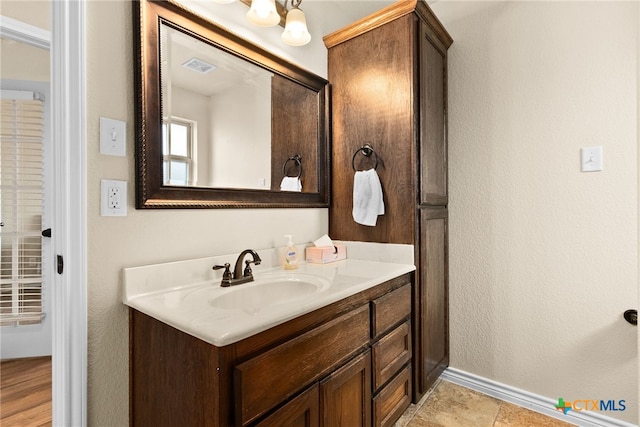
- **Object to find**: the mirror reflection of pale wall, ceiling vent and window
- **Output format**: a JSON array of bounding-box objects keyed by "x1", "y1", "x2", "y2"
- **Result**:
[{"x1": 160, "y1": 25, "x2": 273, "y2": 190}]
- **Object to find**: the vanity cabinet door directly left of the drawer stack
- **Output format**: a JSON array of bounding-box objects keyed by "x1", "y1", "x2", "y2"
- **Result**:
[{"x1": 320, "y1": 350, "x2": 371, "y2": 427}]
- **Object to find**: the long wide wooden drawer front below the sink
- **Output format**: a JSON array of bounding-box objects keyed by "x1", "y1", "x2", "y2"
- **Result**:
[{"x1": 234, "y1": 305, "x2": 370, "y2": 425}]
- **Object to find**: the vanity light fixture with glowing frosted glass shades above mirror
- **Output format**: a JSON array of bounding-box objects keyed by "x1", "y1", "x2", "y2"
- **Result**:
[{"x1": 218, "y1": 0, "x2": 311, "y2": 46}]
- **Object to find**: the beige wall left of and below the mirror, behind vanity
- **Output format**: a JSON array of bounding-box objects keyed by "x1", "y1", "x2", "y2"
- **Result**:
[{"x1": 87, "y1": 1, "x2": 328, "y2": 426}]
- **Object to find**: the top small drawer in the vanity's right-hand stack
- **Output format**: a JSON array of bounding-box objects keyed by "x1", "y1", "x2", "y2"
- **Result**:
[{"x1": 371, "y1": 285, "x2": 411, "y2": 338}]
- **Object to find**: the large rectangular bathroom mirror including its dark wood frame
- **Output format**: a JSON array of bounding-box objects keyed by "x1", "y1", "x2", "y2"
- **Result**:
[{"x1": 132, "y1": 0, "x2": 329, "y2": 208}]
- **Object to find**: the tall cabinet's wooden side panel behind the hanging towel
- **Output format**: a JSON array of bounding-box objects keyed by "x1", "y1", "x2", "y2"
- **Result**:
[{"x1": 328, "y1": 15, "x2": 417, "y2": 244}]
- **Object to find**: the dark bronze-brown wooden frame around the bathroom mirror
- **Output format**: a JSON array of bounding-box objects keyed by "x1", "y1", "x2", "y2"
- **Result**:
[{"x1": 132, "y1": 0, "x2": 330, "y2": 209}]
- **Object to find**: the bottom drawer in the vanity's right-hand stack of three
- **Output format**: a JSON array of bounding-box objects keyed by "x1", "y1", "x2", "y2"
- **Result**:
[{"x1": 373, "y1": 365, "x2": 411, "y2": 427}]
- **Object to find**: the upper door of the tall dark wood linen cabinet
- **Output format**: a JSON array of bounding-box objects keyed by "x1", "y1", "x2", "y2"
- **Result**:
[{"x1": 419, "y1": 23, "x2": 447, "y2": 205}]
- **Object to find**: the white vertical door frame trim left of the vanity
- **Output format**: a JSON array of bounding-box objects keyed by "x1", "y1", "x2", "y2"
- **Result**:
[{"x1": 50, "y1": 0, "x2": 87, "y2": 426}]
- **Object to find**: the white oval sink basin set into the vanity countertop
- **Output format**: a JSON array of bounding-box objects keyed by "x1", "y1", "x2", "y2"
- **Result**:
[{"x1": 208, "y1": 273, "x2": 330, "y2": 314}]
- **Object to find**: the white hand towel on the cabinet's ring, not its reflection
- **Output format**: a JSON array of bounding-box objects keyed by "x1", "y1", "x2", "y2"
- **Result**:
[{"x1": 353, "y1": 169, "x2": 384, "y2": 227}]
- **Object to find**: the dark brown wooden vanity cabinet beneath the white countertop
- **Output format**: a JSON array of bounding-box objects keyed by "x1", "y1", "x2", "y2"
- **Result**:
[{"x1": 130, "y1": 273, "x2": 415, "y2": 427}]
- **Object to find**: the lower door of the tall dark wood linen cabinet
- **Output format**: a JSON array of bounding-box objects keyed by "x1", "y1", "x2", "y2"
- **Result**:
[{"x1": 419, "y1": 208, "x2": 449, "y2": 391}]
